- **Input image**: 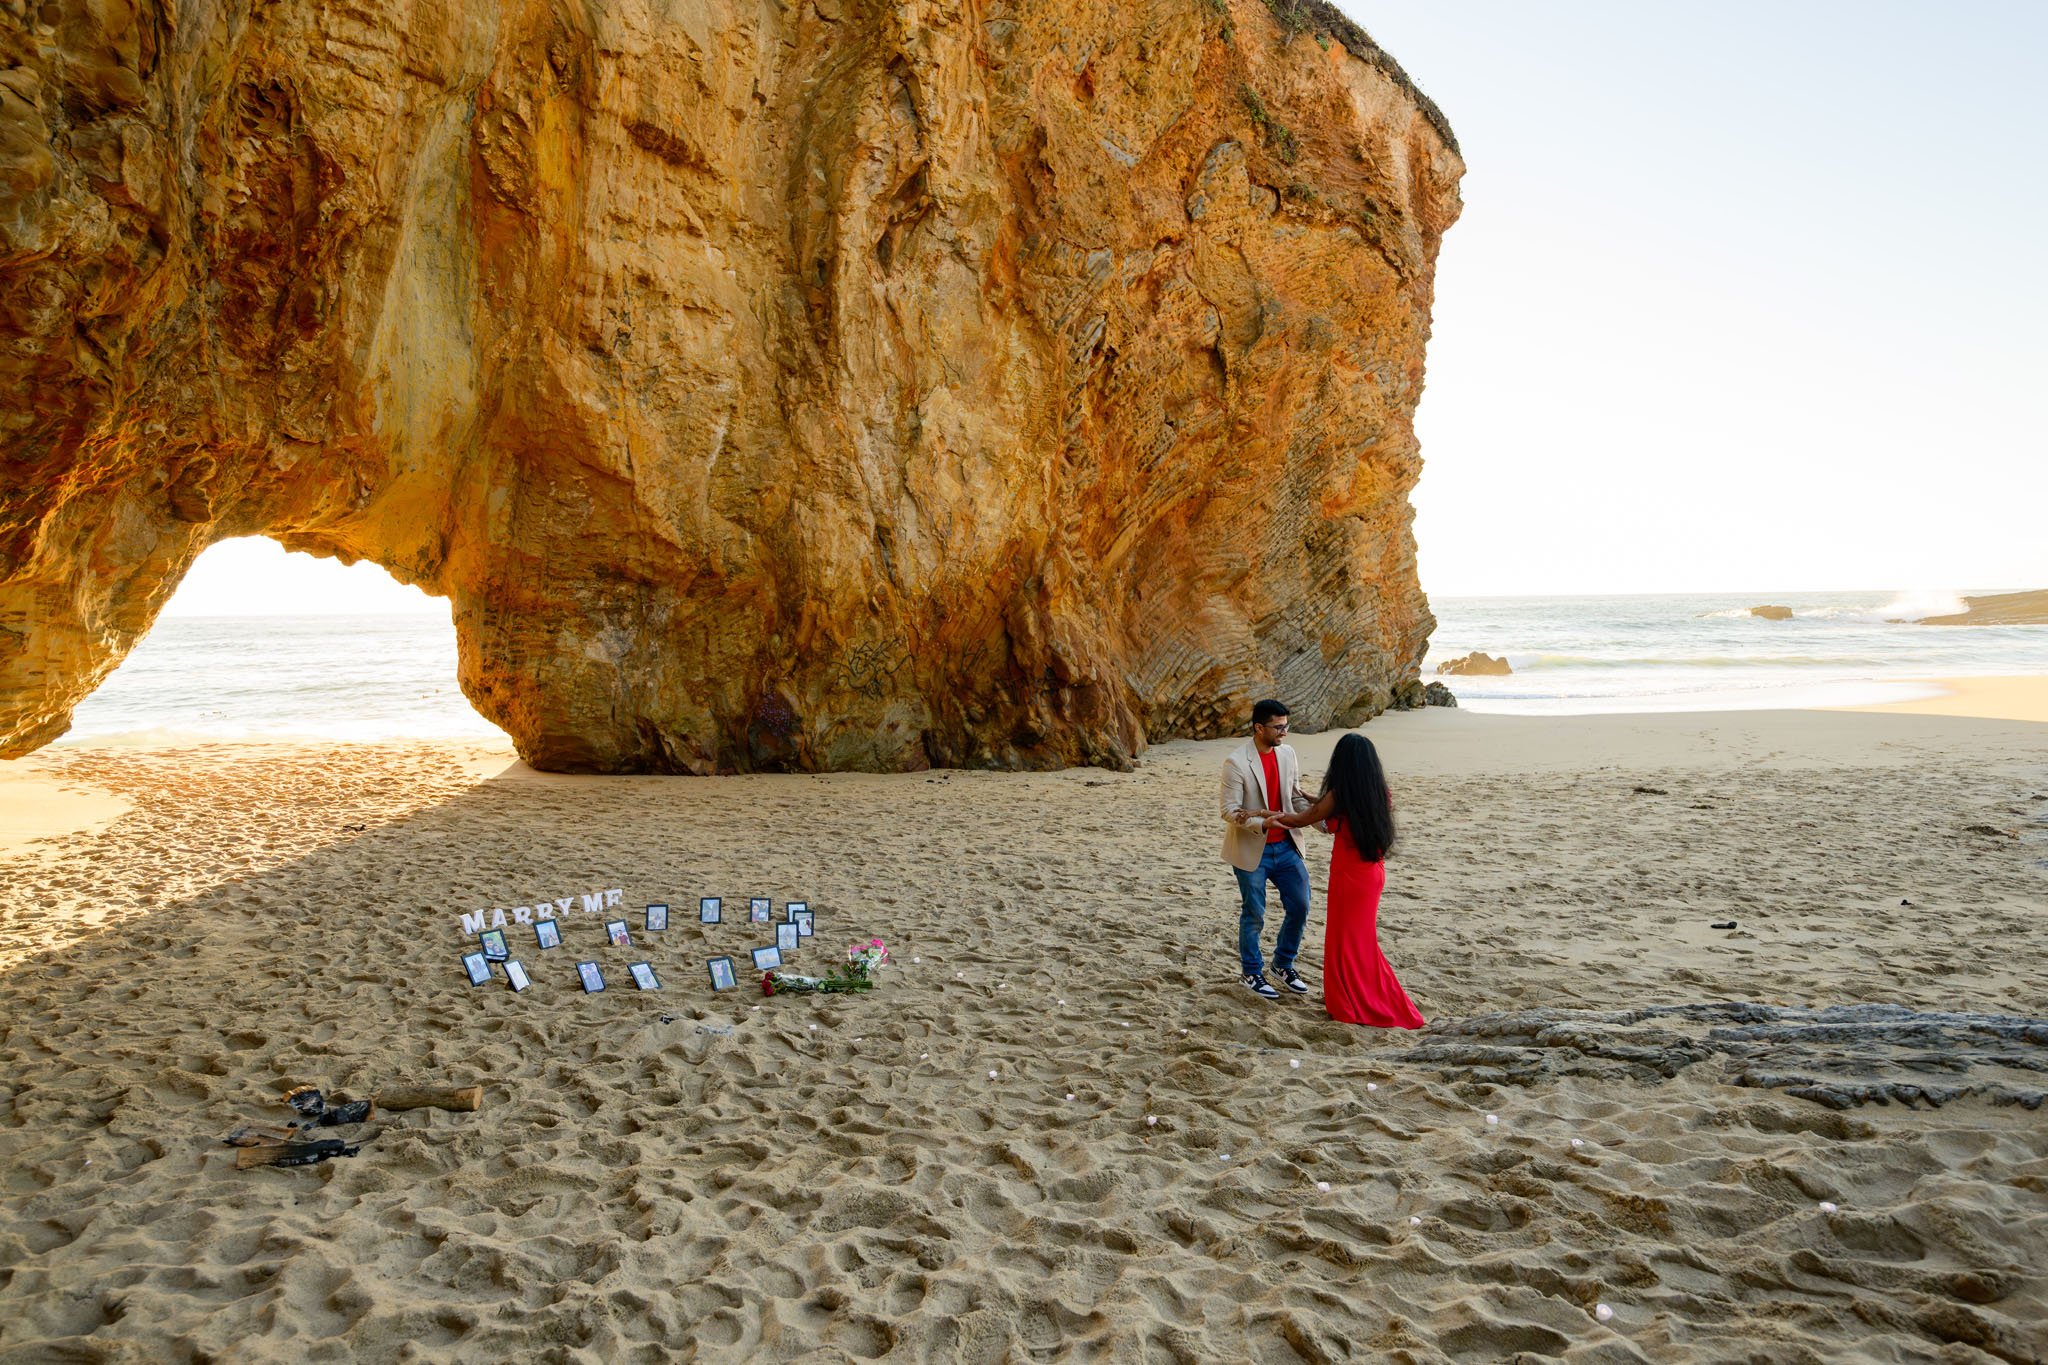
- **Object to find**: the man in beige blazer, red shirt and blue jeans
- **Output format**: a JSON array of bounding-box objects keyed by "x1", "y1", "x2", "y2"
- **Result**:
[{"x1": 1221, "y1": 700, "x2": 1311, "y2": 1001}]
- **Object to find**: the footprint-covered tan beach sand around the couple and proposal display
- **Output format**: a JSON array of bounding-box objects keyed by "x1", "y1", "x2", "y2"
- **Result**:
[{"x1": 0, "y1": 699, "x2": 2048, "y2": 1361}]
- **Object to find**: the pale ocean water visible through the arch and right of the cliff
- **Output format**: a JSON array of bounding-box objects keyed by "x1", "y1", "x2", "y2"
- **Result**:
[{"x1": 56, "y1": 591, "x2": 2048, "y2": 745}]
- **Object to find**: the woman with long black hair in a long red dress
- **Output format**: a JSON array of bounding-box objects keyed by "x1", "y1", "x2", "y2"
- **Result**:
[{"x1": 1268, "y1": 735, "x2": 1423, "y2": 1029}]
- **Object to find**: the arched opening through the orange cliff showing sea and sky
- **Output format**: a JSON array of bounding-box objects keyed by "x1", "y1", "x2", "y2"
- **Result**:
[{"x1": 70, "y1": 536, "x2": 504, "y2": 743}]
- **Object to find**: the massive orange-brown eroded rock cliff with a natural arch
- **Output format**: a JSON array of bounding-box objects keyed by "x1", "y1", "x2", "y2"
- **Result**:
[{"x1": 0, "y1": 0, "x2": 1462, "y2": 772}]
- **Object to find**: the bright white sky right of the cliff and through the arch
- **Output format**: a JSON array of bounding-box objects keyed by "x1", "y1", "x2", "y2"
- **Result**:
[{"x1": 168, "y1": 0, "x2": 2048, "y2": 614}]
